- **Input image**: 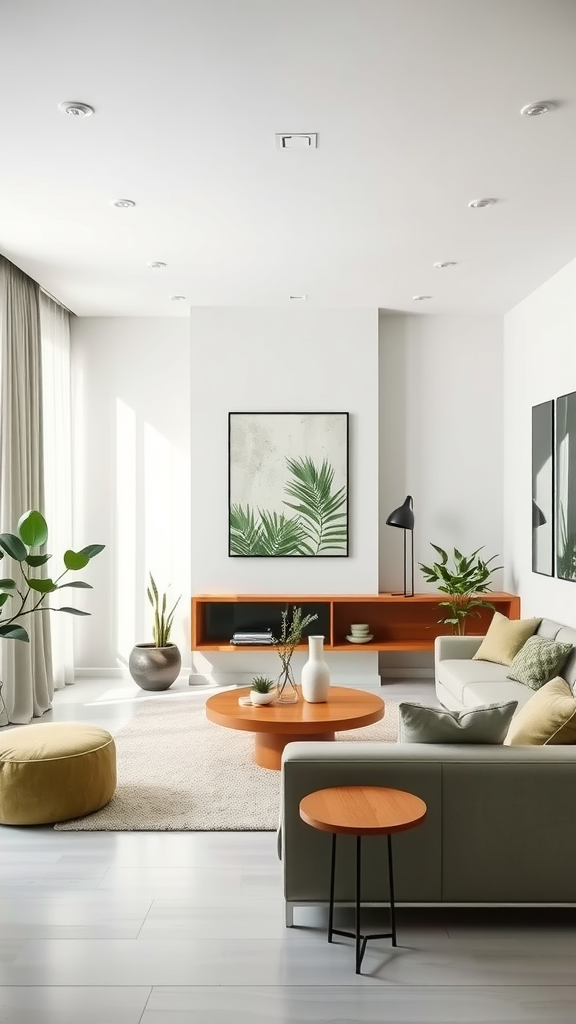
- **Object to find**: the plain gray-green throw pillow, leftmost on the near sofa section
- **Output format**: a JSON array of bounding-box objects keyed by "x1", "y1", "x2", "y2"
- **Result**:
[{"x1": 398, "y1": 700, "x2": 518, "y2": 743}]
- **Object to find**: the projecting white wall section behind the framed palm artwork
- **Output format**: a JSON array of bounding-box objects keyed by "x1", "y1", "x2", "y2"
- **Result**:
[{"x1": 191, "y1": 306, "x2": 378, "y2": 678}]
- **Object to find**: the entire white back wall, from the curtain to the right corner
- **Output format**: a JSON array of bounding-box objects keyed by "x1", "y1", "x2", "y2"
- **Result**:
[{"x1": 72, "y1": 306, "x2": 508, "y2": 672}]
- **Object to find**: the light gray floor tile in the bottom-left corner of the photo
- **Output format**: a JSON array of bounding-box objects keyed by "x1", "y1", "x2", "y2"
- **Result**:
[{"x1": 0, "y1": 985, "x2": 151, "y2": 1024}]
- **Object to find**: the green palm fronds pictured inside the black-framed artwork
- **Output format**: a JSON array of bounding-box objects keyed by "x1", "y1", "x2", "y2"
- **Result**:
[{"x1": 230, "y1": 457, "x2": 346, "y2": 556}]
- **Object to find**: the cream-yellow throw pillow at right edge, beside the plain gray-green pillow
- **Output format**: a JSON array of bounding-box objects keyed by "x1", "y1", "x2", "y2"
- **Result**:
[{"x1": 504, "y1": 676, "x2": 576, "y2": 746}]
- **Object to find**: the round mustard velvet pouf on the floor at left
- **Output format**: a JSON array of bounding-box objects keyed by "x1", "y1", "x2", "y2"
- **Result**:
[{"x1": 0, "y1": 722, "x2": 116, "y2": 825}]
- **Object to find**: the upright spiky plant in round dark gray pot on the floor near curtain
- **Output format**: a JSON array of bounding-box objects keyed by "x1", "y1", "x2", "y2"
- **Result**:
[{"x1": 128, "y1": 572, "x2": 181, "y2": 691}]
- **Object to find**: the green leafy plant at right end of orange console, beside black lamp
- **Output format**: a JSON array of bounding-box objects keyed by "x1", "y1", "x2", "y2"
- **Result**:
[{"x1": 419, "y1": 544, "x2": 502, "y2": 636}]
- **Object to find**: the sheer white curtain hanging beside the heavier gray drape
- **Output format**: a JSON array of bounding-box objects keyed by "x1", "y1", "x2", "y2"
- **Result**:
[{"x1": 40, "y1": 292, "x2": 74, "y2": 689}]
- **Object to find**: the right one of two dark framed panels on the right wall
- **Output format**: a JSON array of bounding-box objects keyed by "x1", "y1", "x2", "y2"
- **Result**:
[{"x1": 556, "y1": 391, "x2": 576, "y2": 581}]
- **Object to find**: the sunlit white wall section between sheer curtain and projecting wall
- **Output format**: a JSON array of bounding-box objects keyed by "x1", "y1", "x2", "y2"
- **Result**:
[{"x1": 72, "y1": 317, "x2": 191, "y2": 669}]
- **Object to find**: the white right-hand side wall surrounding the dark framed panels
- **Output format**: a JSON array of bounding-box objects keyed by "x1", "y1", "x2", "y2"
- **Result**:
[{"x1": 504, "y1": 260, "x2": 576, "y2": 625}]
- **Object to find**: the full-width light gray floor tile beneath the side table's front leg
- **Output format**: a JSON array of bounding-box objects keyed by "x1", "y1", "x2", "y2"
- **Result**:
[{"x1": 6, "y1": 937, "x2": 574, "y2": 986}]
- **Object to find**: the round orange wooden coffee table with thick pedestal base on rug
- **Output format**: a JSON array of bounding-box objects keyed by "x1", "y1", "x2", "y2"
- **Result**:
[{"x1": 206, "y1": 686, "x2": 384, "y2": 771}]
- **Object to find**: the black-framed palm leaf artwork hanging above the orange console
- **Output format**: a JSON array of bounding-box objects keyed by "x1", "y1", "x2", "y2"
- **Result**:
[{"x1": 229, "y1": 413, "x2": 348, "y2": 558}]
